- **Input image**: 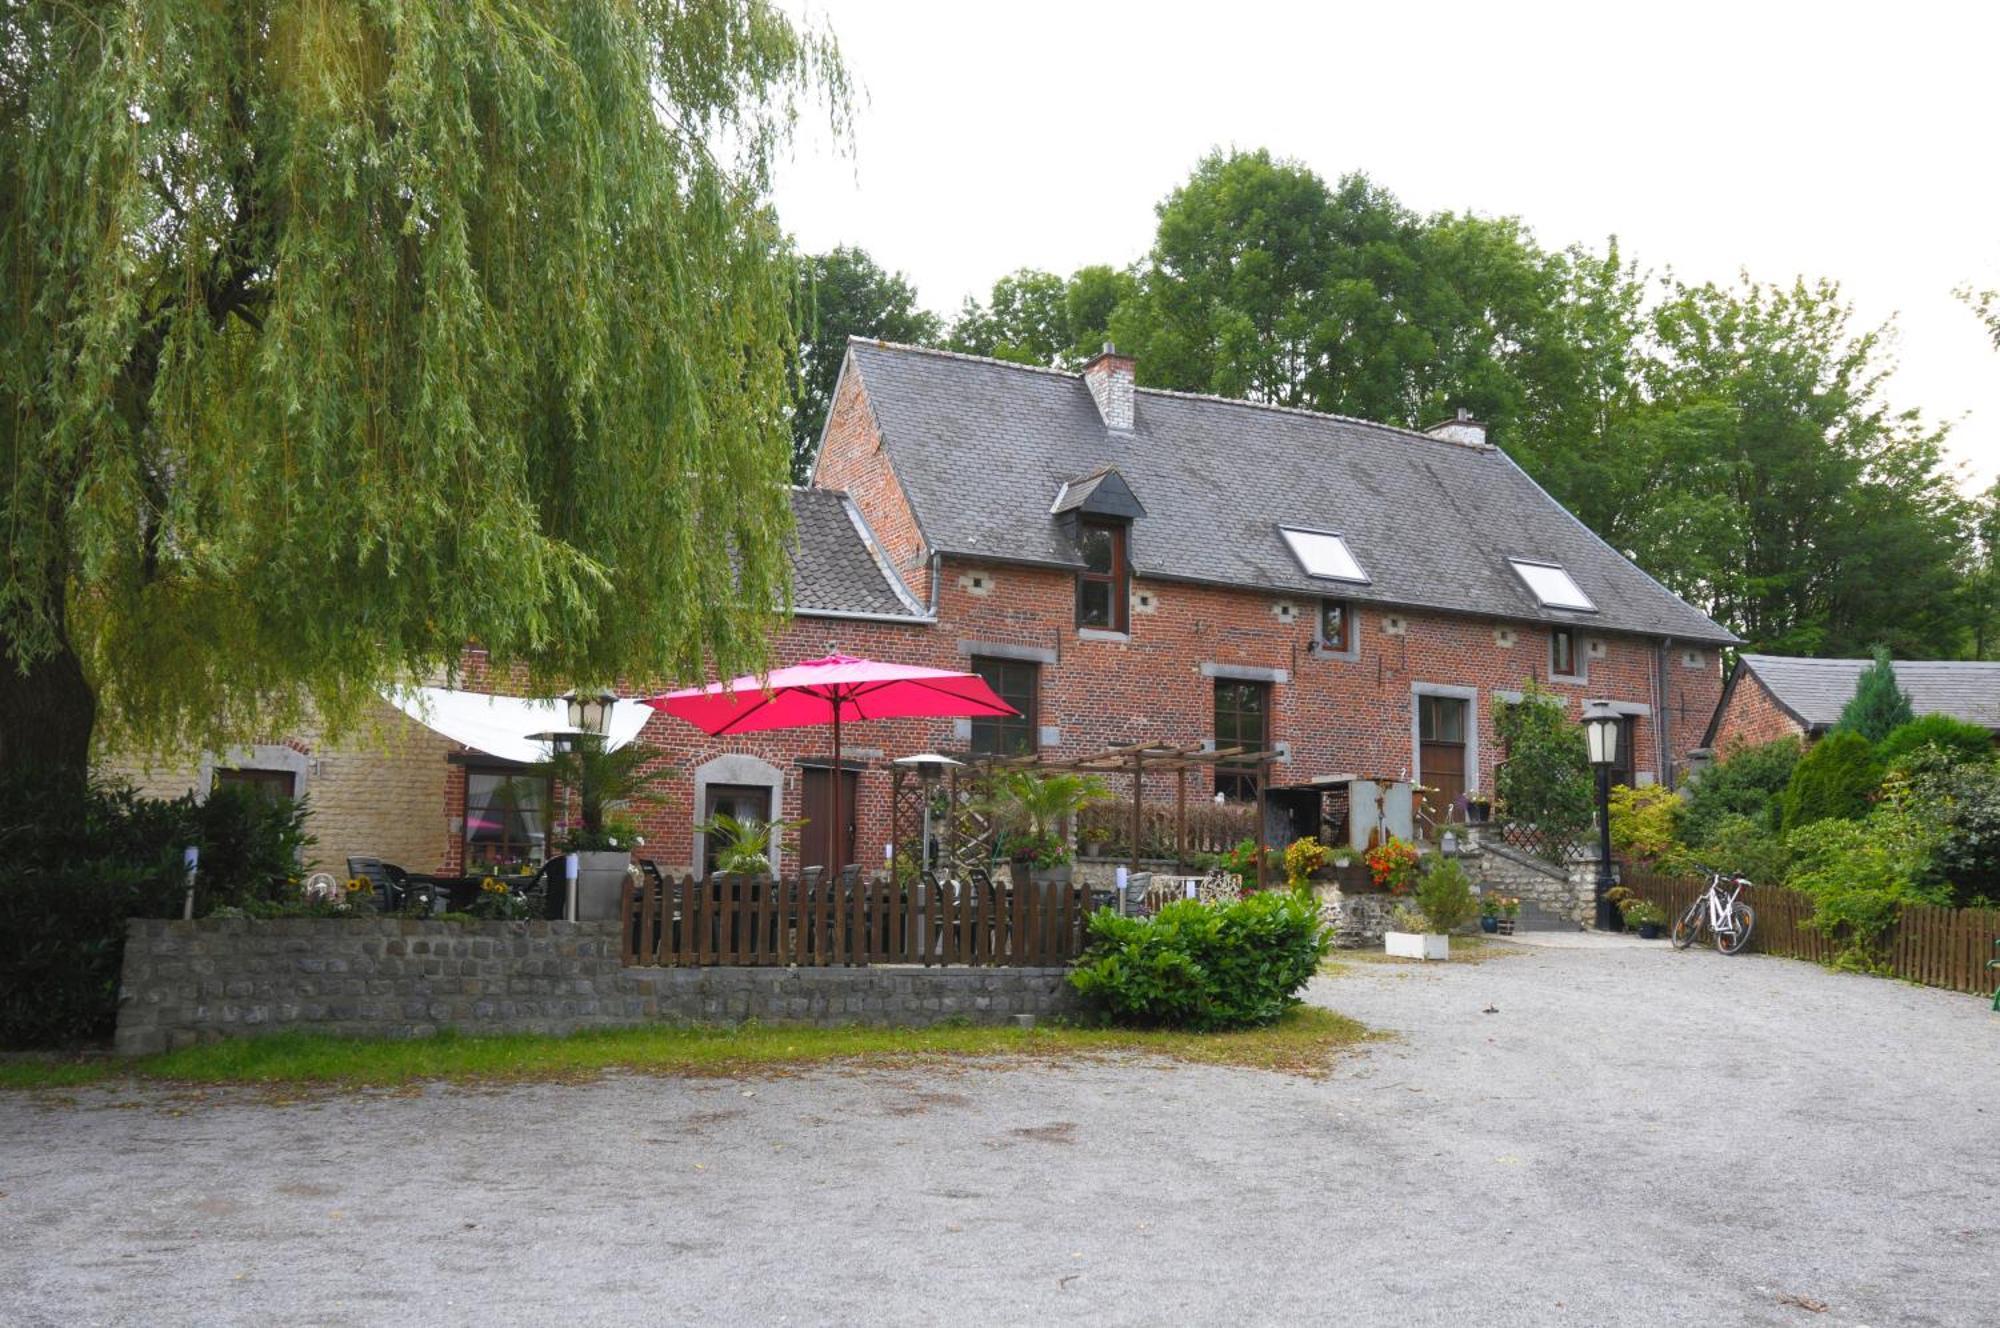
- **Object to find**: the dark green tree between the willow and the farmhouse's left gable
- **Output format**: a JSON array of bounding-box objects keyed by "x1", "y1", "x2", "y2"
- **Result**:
[{"x1": 792, "y1": 246, "x2": 944, "y2": 484}]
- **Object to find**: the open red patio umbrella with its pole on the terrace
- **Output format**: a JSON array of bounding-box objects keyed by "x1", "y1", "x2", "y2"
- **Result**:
[{"x1": 646, "y1": 654, "x2": 1020, "y2": 872}]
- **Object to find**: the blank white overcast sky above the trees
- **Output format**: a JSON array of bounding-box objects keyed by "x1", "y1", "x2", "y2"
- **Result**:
[{"x1": 778, "y1": 0, "x2": 2000, "y2": 486}]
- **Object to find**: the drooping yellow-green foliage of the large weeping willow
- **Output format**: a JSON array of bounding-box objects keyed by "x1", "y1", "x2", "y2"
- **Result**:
[{"x1": 0, "y1": 0, "x2": 848, "y2": 774}]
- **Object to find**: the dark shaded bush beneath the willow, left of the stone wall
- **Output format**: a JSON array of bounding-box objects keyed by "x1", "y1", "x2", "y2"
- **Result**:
[{"x1": 0, "y1": 780, "x2": 312, "y2": 1048}]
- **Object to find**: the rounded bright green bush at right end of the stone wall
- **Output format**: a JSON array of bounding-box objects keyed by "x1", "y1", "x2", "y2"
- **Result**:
[{"x1": 1070, "y1": 890, "x2": 1332, "y2": 1032}]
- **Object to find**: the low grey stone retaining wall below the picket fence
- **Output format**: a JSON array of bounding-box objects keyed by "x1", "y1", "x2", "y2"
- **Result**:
[{"x1": 116, "y1": 918, "x2": 1080, "y2": 1056}]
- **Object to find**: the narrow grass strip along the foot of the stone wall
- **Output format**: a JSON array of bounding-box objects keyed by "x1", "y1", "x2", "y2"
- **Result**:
[{"x1": 0, "y1": 1006, "x2": 1368, "y2": 1088}]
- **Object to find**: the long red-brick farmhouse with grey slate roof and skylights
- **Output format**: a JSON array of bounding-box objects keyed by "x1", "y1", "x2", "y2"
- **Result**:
[{"x1": 105, "y1": 340, "x2": 1734, "y2": 870}]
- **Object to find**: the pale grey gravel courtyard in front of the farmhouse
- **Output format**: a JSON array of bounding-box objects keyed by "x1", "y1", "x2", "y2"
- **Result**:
[{"x1": 0, "y1": 942, "x2": 2000, "y2": 1328}]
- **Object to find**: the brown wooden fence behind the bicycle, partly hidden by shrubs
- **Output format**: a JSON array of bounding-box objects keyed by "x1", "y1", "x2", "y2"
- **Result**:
[{"x1": 1626, "y1": 872, "x2": 2000, "y2": 996}]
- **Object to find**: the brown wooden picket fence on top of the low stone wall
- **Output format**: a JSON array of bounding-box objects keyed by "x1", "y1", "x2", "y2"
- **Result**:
[{"x1": 620, "y1": 876, "x2": 1086, "y2": 968}]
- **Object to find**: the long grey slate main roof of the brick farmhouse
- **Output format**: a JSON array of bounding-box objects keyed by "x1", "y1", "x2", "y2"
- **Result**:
[{"x1": 848, "y1": 340, "x2": 1736, "y2": 644}]
